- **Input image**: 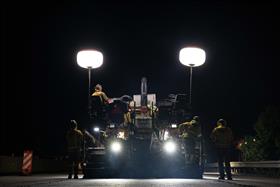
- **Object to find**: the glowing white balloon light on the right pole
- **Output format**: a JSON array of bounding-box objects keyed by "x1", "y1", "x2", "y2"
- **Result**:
[{"x1": 179, "y1": 47, "x2": 206, "y2": 67}]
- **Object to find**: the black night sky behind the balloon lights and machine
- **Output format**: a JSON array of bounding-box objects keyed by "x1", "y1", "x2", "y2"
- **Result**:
[{"x1": 1, "y1": 1, "x2": 280, "y2": 155}]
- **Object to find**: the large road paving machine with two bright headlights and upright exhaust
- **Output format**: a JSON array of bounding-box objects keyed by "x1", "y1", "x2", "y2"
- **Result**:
[{"x1": 83, "y1": 78, "x2": 203, "y2": 178}]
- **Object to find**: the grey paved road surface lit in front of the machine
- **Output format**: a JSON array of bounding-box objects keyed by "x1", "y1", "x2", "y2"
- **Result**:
[{"x1": 0, "y1": 174, "x2": 280, "y2": 187}]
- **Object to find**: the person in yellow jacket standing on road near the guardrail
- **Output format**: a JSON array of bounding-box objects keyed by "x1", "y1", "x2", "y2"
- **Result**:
[{"x1": 210, "y1": 119, "x2": 233, "y2": 180}]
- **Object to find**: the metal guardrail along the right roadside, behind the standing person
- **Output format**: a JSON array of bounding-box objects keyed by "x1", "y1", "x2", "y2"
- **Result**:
[{"x1": 205, "y1": 160, "x2": 280, "y2": 176}]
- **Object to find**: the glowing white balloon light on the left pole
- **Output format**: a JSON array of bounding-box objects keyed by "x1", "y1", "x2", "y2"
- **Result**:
[{"x1": 77, "y1": 50, "x2": 103, "y2": 68}]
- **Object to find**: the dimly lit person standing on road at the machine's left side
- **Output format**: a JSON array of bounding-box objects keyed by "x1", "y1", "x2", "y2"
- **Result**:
[{"x1": 66, "y1": 120, "x2": 83, "y2": 179}]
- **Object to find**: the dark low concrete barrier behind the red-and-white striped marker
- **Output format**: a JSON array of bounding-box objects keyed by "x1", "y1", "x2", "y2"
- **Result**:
[{"x1": 0, "y1": 156, "x2": 67, "y2": 175}]
